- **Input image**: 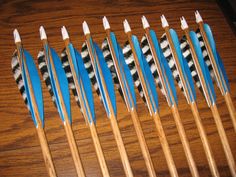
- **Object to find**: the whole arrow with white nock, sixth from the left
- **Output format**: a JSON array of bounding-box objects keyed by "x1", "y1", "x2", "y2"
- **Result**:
[{"x1": 123, "y1": 20, "x2": 178, "y2": 176}]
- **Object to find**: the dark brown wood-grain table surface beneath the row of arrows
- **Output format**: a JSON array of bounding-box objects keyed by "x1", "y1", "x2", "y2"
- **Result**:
[{"x1": 0, "y1": 0, "x2": 236, "y2": 177}]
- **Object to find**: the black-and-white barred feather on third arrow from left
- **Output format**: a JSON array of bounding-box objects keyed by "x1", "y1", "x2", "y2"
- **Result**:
[{"x1": 61, "y1": 48, "x2": 81, "y2": 108}]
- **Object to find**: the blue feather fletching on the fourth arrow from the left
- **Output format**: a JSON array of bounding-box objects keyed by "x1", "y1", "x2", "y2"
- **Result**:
[{"x1": 90, "y1": 39, "x2": 117, "y2": 117}]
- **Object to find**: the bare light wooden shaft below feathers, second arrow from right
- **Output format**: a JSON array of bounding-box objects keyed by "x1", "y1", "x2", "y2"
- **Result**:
[{"x1": 210, "y1": 104, "x2": 236, "y2": 176}]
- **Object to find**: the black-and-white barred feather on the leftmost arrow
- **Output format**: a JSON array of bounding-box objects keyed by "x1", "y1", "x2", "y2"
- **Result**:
[{"x1": 11, "y1": 51, "x2": 30, "y2": 111}]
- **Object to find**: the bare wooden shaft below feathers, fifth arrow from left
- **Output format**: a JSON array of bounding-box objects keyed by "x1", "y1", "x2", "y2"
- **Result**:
[{"x1": 130, "y1": 109, "x2": 156, "y2": 177}]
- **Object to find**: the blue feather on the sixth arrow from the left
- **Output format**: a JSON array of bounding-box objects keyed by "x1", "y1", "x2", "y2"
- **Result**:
[{"x1": 132, "y1": 35, "x2": 158, "y2": 113}]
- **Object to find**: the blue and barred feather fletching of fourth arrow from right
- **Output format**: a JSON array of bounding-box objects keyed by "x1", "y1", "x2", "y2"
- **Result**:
[{"x1": 141, "y1": 30, "x2": 178, "y2": 105}]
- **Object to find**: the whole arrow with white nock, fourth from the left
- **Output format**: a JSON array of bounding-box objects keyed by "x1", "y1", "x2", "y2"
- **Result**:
[{"x1": 82, "y1": 21, "x2": 133, "y2": 177}]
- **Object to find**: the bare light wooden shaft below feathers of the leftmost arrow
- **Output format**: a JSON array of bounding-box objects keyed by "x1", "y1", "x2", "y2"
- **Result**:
[{"x1": 36, "y1": 126, "x2": 57, "y2": 177}]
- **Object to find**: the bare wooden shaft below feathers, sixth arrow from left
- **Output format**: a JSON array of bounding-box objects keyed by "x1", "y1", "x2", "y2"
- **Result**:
[{"x1": 153, "y1": 113, "x2": 179, "y2": 177}]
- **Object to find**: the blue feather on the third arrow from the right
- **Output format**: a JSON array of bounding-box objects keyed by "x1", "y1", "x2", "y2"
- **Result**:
[{"x1": 170, "y1": 29, "x2": 196, "y2": 102}]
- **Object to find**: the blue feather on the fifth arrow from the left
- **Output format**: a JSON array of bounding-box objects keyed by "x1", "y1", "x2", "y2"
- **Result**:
[{"x1": 110, "y1": 32, "x2": 136, "y2": 109}]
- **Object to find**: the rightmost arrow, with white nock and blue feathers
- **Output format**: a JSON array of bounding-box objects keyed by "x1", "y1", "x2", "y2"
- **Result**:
[{"x1": 195, "y1": 11, "x2": 236, "y2": 132}]
